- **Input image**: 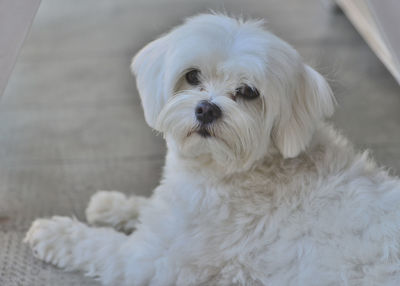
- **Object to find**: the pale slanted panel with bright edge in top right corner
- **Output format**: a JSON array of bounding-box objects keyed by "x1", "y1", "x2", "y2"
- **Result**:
[{"x1": 336, "y1": 0, "x2": 400, "y2": 84}]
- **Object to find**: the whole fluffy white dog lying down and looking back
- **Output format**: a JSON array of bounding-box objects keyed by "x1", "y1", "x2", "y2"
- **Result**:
[{"x1": 25, "y1": 14, "x2": 400, "y2": 286}]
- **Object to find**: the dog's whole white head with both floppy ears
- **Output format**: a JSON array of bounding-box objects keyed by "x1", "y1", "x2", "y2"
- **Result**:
[{"x1": 132, "y1": 14, "x2": 334, "y2": 171}]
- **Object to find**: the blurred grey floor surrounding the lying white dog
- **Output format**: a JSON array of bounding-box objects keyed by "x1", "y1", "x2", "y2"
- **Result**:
[{"x1": 0, "y1": 0, "x2": 400, "y2": 286}]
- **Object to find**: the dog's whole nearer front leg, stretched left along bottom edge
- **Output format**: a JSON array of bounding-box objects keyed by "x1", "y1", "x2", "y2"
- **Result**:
[{"x1": 24, "y1": 217, "x2": 167, "y2": 286}]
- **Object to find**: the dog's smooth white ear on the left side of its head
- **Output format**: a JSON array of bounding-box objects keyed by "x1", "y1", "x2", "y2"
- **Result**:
[{"x1": 131, "y1": 35, "x2": 170, "y2": 128}]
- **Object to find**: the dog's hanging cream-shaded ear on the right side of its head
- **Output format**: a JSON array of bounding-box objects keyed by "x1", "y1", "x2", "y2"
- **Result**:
[{"x1": 272, "y1": 65, "x2": 336, "y2": 158}]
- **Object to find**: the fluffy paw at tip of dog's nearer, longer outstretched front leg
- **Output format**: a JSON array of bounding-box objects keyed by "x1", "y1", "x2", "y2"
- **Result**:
[{"x1": 24, "y1": 217, "x2": 79, "y2": 267}]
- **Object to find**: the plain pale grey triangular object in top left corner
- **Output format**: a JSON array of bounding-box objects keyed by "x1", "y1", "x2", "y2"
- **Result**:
[{"x1": 0, "y1": 0, "x2": 40, "y2": 96}]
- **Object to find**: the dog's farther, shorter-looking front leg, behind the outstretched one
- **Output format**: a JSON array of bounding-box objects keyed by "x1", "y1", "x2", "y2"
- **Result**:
[{"x1": 86, "y1": 191, "x2": 148, "y2": 233}]
